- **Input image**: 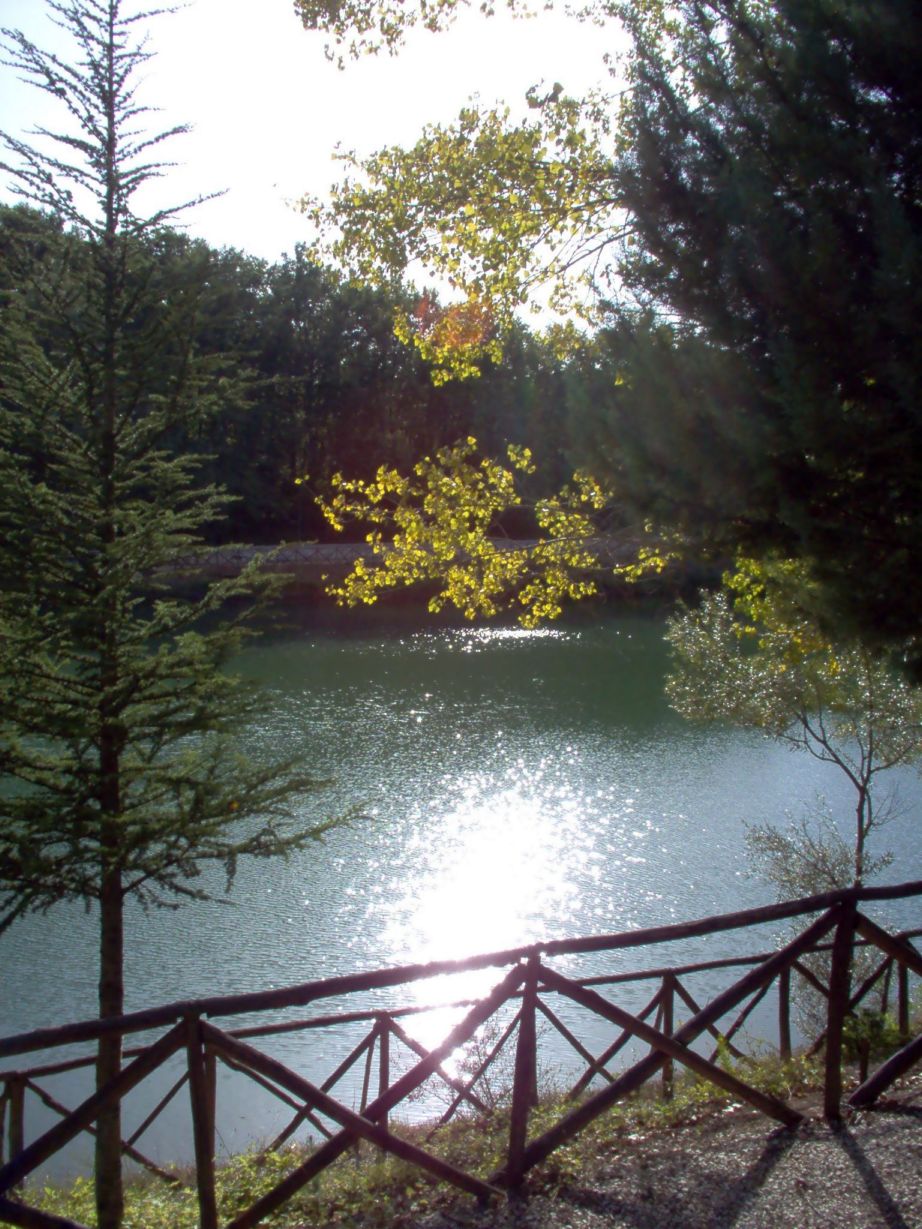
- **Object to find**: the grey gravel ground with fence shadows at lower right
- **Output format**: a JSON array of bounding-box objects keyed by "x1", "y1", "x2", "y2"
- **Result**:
[{"x1": 414, "y1": 1074, "x2": 922, "y2": 1229}]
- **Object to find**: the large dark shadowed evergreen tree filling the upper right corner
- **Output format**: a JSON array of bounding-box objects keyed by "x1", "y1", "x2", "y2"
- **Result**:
[{"x1": 602, "y1": 0, "x2": 922, "y2": 651}]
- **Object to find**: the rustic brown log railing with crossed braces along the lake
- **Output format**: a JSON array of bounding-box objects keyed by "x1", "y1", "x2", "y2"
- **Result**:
[{"x1": 0, "y1": 882, "x2": 922, "y2": 1229}]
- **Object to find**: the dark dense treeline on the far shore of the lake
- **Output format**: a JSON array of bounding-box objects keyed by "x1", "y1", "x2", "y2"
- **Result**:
[{"x1": 0, "y1": 206, "x2": 610, "y2": 542}]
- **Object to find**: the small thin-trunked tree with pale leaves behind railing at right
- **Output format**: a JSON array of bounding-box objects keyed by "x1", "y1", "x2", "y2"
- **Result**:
[{"x1": 666, "y1": 560, "x2": 922, "y2": 898}]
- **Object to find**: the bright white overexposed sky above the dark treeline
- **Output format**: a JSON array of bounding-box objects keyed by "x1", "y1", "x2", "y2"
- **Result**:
[{"x1": 0, "y1": 0, "x2": 611, "y2": 259}]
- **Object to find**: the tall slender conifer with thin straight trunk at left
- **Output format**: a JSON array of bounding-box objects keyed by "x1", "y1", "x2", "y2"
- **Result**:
[{"x1": 0, "y1": 0, "x2": 329, "y2": 1229}]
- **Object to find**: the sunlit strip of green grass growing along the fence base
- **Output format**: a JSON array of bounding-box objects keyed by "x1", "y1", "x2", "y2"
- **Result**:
[{"x1": 27, "y1": 1056, "x2": 822, "y2": 1229}]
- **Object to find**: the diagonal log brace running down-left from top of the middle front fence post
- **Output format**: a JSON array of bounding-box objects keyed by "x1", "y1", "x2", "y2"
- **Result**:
[{"x1": 220, "y1": 965, "x2": 525, "y2": 1229}]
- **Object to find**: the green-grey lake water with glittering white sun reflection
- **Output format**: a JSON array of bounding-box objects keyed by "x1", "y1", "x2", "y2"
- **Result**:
[{"x1": 0, "y1": 617, "x2": 922, "y2": 1164}]
